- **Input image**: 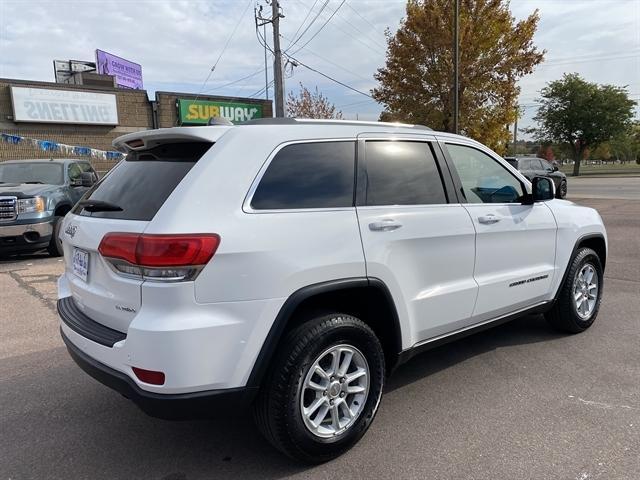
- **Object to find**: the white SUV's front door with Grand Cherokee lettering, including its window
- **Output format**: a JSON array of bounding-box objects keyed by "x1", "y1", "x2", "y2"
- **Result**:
[{"x1": 441, "y1": 139, "x2": 557, "y2": 322}]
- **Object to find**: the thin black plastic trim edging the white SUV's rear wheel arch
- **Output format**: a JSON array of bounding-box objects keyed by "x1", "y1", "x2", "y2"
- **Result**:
[{"x1": 247, "y1": 277, "x2": 402, "y2": 388}]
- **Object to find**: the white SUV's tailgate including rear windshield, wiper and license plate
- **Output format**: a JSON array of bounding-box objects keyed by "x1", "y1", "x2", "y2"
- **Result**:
[{"x1": 60, "y1": 139, "x2": 212, "y2": 332}]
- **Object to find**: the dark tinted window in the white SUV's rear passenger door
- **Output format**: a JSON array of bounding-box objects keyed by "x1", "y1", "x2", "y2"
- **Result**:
[{"x1": 364, "y1": 141, "x2": 447, "y2": 205}]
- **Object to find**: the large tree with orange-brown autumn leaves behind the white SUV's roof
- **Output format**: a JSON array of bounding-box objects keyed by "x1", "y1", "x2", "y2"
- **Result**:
[{"x1": 371, "y1": 0, "x2": 544, "y2": 152}]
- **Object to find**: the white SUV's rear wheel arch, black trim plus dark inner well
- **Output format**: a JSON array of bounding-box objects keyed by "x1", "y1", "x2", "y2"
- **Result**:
[{"x1": 247, "y1": 277, "x2": 402, "y2": 387}]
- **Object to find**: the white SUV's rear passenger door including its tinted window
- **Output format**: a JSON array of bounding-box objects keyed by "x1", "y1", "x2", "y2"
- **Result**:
[{"x1": 356, "y1": 135, "x2": 477, "y2": 348}]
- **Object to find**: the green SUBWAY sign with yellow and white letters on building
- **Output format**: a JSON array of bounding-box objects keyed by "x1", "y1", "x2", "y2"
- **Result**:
[{"x1": 178, "y1": 98, "x2": 262, "y2": 125}]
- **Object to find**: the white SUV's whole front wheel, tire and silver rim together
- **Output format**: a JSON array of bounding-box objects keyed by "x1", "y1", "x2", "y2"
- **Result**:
[{"x1": 546, "y1": 248, "x2": 603, "y2": 333}]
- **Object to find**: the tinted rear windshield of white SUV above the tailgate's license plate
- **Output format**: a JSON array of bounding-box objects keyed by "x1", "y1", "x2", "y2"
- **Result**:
[{"x1": 73, "y1": 142, "x2": 213, "y2": 220}]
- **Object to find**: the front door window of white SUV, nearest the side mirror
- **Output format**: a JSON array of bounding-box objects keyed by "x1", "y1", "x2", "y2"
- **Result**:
[{"x1": 447, "y1": 143, "x2": 524, "y2": 203}]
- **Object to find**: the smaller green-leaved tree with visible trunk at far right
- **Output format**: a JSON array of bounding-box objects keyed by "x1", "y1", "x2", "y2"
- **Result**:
[{"x1": 533, "y1": 73, "x2": 635, "y2": 176}]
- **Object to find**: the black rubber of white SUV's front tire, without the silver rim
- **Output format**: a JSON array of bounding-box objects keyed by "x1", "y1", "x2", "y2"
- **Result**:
[{"x1": 545, "y1": 248, "x2": 604, "y2": 333}]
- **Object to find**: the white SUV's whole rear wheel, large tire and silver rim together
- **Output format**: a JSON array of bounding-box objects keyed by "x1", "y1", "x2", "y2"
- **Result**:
[{"x1": 255, "y1": 313, "x2": 385, "y2": 463}]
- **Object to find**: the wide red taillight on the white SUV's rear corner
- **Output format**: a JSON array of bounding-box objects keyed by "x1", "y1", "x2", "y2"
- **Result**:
[{"x1": 98, "y1": 233, "x2": 220, "y2": 267}]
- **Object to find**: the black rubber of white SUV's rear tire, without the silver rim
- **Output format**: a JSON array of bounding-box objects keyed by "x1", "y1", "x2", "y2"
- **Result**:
[{"x1": 254, "y1": 313, "x2": 385, "y2": 463}]
